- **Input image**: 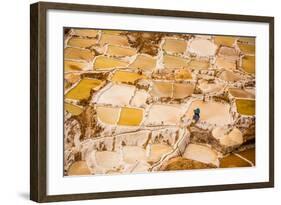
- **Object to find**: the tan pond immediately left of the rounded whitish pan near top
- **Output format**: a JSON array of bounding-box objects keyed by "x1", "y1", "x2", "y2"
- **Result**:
[{"x1": 163, "y1": 39, "x2": 187, "y2": 53}]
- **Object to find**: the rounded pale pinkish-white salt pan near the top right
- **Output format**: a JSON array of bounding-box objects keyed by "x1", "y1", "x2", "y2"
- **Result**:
[{"x1": 188, "y1": 38, "x2": 217, "y2": 57}]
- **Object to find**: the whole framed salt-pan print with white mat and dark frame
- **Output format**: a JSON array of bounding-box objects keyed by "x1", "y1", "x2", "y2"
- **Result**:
[{"x1": 30, "y1": 2, "x2": 274, "y2": 202}]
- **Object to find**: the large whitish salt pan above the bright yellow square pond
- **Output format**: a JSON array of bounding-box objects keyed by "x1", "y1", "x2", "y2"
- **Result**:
[{"x1": 92, "y1": 84, "x2": 136, "y2": 106}]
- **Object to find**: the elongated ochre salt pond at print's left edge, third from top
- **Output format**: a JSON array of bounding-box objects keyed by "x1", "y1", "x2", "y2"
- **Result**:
[{"x1": 64, "y1": 47, "x2": 94, "y2": 61}]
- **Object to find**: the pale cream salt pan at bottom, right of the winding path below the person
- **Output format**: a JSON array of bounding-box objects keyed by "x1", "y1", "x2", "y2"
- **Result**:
[{"x1": 183, "y1": 144, "x2": 220, "y2": 167}]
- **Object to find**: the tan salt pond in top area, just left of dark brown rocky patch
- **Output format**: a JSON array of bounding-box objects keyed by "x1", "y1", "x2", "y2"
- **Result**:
[{"x1": 99, "y1": 33, "x2": 129, "y2": 46}]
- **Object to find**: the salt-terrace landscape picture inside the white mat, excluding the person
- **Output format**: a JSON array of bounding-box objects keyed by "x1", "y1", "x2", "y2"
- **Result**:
[{"x1": 64, "y1": 29, "x2": 255, "y2": 176}]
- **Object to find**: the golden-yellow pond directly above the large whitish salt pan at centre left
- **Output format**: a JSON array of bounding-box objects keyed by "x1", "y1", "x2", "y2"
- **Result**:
[{"x1": 111, "y1": 70, "x2": 145, "y2": 83}]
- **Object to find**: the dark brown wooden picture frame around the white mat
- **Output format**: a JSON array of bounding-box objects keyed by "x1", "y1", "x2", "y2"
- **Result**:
[{"x1": 30, "y1": 2, "x2": 274, "y2": 202}]
